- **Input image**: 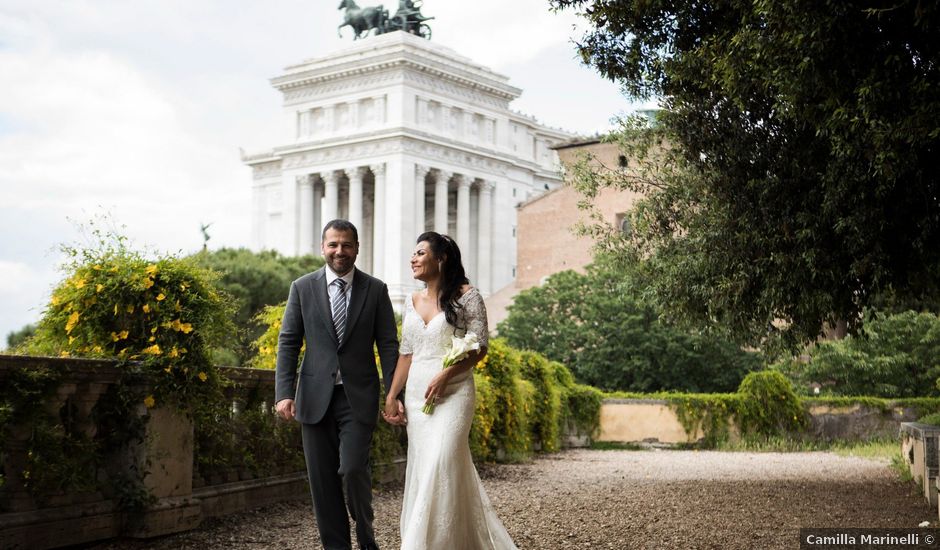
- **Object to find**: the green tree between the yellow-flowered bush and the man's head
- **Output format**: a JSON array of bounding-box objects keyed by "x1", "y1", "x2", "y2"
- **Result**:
[{"x1": 193, "y1": 248, "x2": 323, "y2": 366}]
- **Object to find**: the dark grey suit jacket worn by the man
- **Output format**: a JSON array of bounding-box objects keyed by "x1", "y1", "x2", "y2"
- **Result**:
[{"x1": 274, "y1": 267, "x2": 398, "y2": 425}]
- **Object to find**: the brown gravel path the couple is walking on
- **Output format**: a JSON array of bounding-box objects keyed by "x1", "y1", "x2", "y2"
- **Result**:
[{"x1": 91, "y1": 450, "x2": 937, "y2": 550}]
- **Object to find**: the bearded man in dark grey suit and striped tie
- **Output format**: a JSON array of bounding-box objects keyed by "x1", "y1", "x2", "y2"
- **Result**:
[{"x1": 275, "y1": 220, "x2": 398, "y2": 550}]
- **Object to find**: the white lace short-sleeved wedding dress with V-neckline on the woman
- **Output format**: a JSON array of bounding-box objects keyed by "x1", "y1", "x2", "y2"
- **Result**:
[{"x1": 401, "y1": 289, "x2": 516, "y2": 550}]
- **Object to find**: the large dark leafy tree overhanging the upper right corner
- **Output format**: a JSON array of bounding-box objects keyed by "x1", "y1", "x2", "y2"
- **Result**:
[{"x1": 551, "y1": 0, "x2": 940, "y2": 346}]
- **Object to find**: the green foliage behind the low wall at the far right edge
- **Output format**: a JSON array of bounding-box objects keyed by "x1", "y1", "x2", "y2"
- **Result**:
[{"x1": 780, "y1": 311, "x2": 940, "y2": 397}]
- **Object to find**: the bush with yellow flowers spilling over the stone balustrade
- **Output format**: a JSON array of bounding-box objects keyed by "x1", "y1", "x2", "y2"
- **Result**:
[{"x1": 22, "y1": 233, "x2": 232, "y2": 407}]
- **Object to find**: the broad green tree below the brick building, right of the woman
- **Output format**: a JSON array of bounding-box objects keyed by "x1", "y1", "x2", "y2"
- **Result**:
[{"x1": 498, "y1": 264, "x2": 759, "y2": 392}]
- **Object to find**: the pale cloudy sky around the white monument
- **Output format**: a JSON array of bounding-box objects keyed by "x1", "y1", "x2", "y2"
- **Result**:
[{"x1": 0, "y1": 0, "x2": 648, "y2": 348}]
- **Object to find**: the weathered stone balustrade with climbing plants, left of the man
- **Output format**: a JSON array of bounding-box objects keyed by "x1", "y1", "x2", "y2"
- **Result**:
[{"x1": 0, "y1": 355, "x2": 308, "y2": 549}]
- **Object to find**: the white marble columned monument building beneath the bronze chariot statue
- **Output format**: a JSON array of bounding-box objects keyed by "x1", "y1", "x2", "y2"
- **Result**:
[{"x1": 242, "y1": 32, "x2": 573, "y2": 307}]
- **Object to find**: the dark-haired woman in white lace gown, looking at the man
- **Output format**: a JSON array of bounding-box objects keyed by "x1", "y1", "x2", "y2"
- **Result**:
[{"x1": 382, "y1": 232, "x2": 516, "y2": 550}]
